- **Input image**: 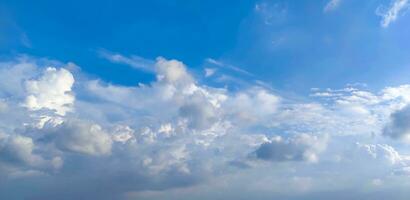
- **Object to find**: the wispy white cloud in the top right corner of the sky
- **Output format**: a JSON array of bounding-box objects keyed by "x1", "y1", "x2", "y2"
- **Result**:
[{"x1": 376, "y1": 0, "x2": 409, "y2": 28}]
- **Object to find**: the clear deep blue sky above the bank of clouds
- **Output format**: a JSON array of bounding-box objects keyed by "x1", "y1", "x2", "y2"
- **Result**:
[{"x1": 1, "y1": 1, "x2": 410, "y2": 92}]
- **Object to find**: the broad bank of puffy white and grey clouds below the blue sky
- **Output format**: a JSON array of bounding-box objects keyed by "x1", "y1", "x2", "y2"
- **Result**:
[{"x1": 0, "y1": 56, "x2": 410, "y2": 199}]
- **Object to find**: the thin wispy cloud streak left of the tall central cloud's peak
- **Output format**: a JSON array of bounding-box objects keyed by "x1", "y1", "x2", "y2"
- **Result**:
[{"x1": 98, "y1": 50, "x2": 155, "y2": 72}]
